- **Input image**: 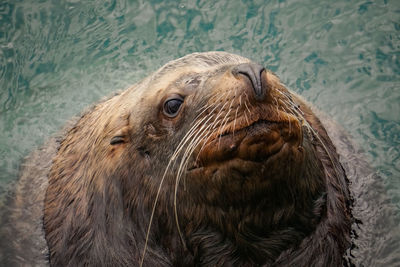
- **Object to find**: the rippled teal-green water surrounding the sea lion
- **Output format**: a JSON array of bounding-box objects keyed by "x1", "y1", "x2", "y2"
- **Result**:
[{"x1": 0, "y1": 0, "x2": 400, "y2": 263}]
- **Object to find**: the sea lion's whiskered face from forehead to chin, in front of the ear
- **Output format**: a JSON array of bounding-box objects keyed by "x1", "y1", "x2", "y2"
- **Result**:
[{"x1": 119, "y1": 52, "x2": 321, "y2": 206}]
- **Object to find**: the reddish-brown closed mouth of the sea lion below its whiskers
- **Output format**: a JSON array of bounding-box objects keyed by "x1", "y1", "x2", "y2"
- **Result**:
[{"x1": 190, "y1": 119, "x2": 301, "y2": 169}]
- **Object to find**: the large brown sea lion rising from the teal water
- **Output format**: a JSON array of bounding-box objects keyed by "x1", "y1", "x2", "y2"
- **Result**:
[{"x1": 3, "y1": 52, "x2": 352, "y2": 266}]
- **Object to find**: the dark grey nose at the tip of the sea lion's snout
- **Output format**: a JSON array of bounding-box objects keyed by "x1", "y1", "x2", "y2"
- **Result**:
[{"x1": 232, "y1": 63, "x2": 267, "y2": 100}]
